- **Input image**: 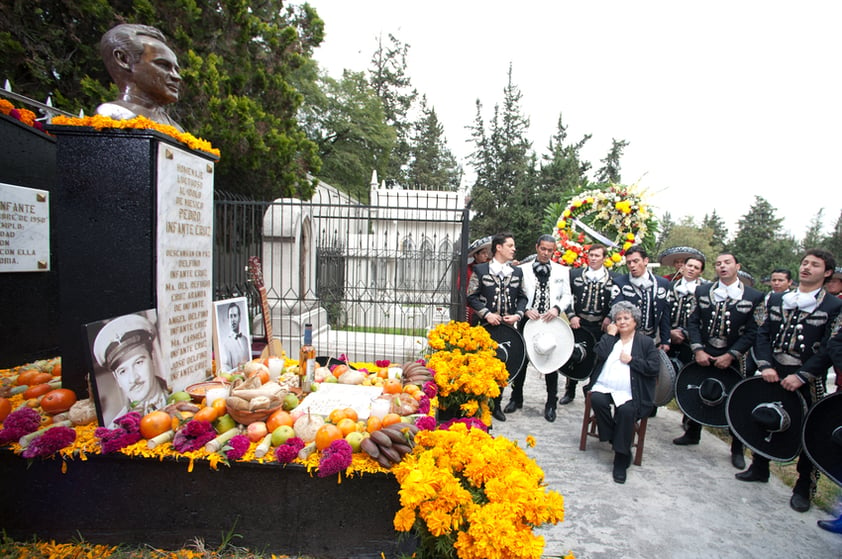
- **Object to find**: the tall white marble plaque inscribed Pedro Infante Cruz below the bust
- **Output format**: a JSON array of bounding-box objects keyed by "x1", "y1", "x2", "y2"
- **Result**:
[{"x1": 157, "y1": 143, "x2": 213, "y2": 391}]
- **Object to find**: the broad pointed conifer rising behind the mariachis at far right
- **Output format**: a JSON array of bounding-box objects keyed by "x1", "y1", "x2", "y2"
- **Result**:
[{"x1": 727, "y1": 196, "x2": 798, "y2": 281}]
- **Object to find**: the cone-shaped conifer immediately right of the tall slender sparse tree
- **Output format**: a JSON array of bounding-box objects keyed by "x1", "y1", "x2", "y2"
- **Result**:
[{"x1": 405, "y1": 96, "x2": 462, "y2": 191}]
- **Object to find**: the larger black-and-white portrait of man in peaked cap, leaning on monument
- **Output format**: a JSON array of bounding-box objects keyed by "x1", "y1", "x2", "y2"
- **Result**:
[{"x1": 85, "y1": 309, "x2": 170, "y2": 427}]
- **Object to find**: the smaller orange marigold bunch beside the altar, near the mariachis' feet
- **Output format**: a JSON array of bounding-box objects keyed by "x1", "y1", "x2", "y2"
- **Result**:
[{"x1": 427, "y1": 321, "x2": 509, "y2": 425}]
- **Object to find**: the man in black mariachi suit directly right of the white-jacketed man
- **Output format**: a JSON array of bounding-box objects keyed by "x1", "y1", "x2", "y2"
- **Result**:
[{"x1": 558, "y1": 243, "x2": 614, "y2": 406}]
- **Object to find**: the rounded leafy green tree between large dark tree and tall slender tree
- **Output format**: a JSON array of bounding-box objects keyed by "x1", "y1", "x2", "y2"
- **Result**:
[{"x1": 295, "y1": 64, "x2": 395, "y2": 202}]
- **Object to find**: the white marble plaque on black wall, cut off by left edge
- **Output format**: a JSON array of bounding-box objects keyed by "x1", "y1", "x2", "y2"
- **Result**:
[{"x1": 0, "y1": 183, "x2": 50, "y2": 273}]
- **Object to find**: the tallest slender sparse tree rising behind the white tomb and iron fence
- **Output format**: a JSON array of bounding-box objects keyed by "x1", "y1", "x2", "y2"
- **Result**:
[{"x1": 369, "y1": 33, "x2": 418, "y2": 184}]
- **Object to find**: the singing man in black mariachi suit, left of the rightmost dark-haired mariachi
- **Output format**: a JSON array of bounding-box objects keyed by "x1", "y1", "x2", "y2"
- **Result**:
[{"x1": 672, "y1": 252, "x2": 763, "y2": 469}]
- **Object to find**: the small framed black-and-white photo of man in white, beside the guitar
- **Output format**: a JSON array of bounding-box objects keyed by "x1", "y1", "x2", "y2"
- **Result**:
[{"x1": 213, "y1": 297, "x2": 251, "y2": 373}]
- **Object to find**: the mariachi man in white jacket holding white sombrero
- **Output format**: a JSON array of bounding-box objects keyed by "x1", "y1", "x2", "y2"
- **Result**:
[{"x1": 503, "y1": 235, "x2": 573, "y2": 422}]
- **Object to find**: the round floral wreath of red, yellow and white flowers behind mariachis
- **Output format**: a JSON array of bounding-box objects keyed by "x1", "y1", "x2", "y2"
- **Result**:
[{"x1": 553, "y1": 183, "x2": 653, "y2": 268}]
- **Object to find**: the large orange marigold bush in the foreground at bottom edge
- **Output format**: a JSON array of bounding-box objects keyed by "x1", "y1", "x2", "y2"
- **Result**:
[{"x1": 392, "y1": 423, "x2": 564, "y2": 559}]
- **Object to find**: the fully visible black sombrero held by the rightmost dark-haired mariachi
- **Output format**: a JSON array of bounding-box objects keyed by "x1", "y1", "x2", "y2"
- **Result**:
[{"x1": 726, "y1": 376, "x2": 807, "y2": 462}]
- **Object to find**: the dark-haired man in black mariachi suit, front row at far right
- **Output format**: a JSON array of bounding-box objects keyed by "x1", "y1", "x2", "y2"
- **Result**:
[{"x1": 736, "y1": 249, "x2": 842, "y2": 512}]
